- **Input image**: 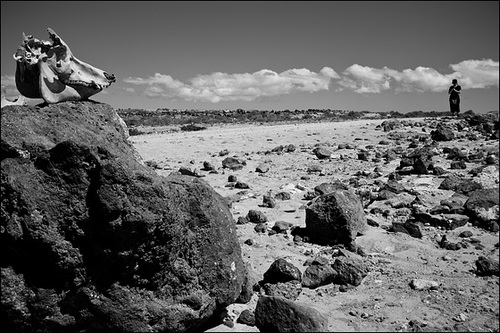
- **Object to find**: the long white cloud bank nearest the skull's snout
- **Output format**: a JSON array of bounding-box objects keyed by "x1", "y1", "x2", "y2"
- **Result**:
[{"x1": 123, "y1": 67, "x2": 340, "y2": 103}]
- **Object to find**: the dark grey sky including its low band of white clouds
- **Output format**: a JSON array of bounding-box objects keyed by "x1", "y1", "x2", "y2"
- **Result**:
[{"x1": 1, "y1": 1, "x2": 500, "y2": 113}]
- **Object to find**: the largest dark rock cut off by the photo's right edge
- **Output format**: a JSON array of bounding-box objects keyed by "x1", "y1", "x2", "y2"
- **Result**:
[{"x1": 464, "y1": 187, "x2": 499, "y2": 226}]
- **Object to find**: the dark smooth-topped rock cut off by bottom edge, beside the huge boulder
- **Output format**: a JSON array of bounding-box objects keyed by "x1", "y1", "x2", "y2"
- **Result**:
[{"x1": 255, "y1": 296, "x2": 328, "y2": 332}]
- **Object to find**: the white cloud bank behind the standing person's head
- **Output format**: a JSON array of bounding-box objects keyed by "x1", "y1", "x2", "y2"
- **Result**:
[{"x1": 339, "y1": 59, "x2": 499, "y2": 93}]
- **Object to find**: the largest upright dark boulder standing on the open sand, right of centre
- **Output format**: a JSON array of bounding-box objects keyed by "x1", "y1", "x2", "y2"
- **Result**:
[{"x1": 306, "y1": 190, "x2": 368, "y2": 248}]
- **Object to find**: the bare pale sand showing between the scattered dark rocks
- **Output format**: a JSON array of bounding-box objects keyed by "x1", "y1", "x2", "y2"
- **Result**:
[{"x1": 130, "y1": 119, "x2": 499, "y2": 332}]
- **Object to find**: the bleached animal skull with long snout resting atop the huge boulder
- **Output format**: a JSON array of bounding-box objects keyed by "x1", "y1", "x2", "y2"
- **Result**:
[{"x1": 14, "y1": 28, "x2": 115, "y2": 104}]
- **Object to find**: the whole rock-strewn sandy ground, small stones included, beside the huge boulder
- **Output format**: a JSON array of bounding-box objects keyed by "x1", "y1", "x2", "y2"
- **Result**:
[{"x1": 129, "y1": 118, "x2": 499, "y2": 332}]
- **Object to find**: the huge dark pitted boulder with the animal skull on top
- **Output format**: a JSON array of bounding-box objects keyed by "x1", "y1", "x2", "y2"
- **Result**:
[{"x1": 0, "y1": 102, "x2": 245, "y2": 332}]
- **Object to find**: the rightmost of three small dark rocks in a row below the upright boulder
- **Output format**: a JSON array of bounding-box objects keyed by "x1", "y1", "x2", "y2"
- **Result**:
[{"x1": 332, "y1": 254, "x2": 370, "y2": 286}]
